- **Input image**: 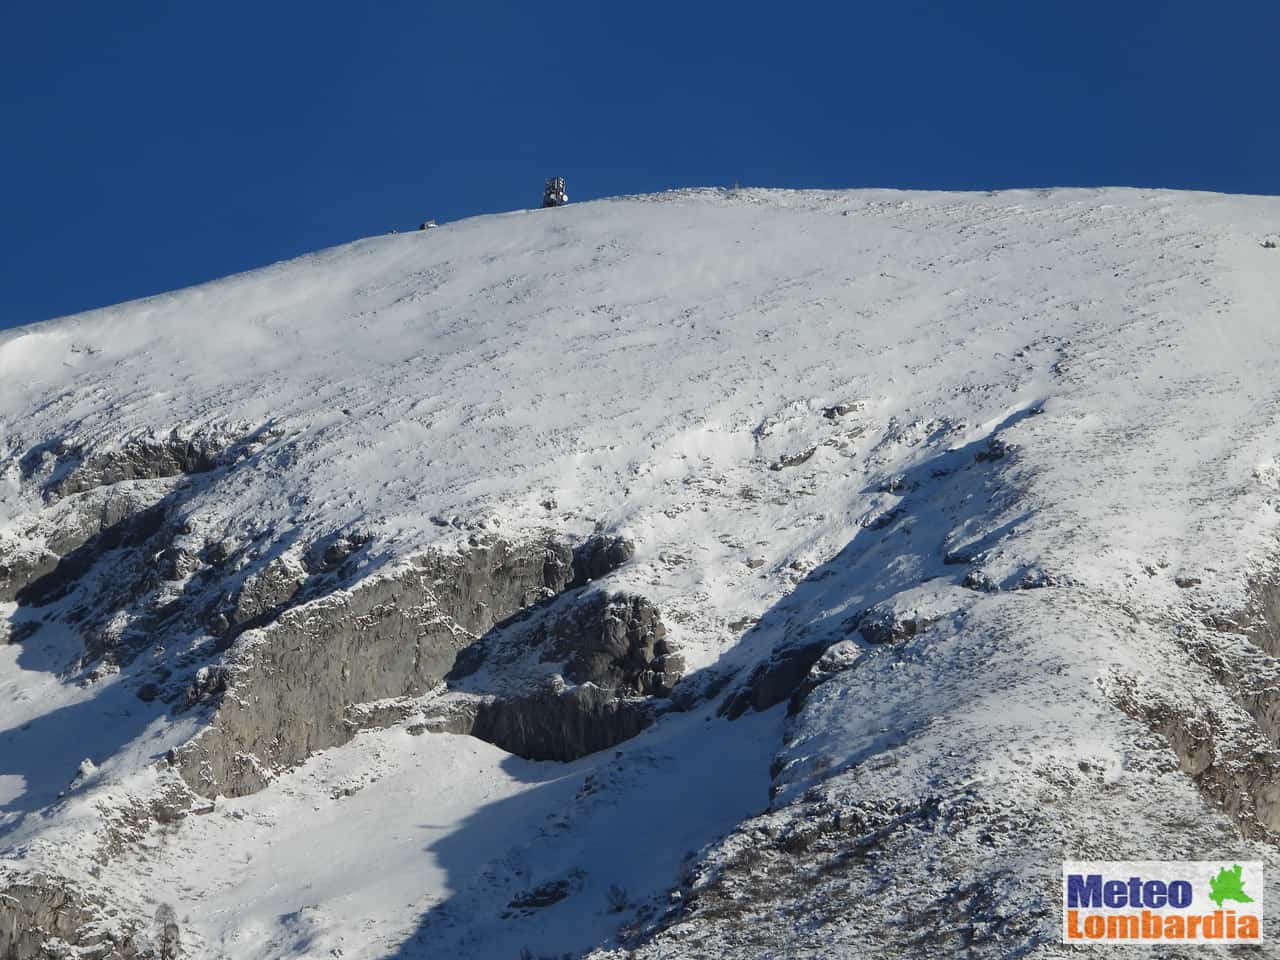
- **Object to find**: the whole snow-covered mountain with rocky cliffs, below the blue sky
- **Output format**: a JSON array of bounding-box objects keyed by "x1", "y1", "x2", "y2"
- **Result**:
[{"x1": 0, "y1": 189, "x2": 1280, "y2": 959}]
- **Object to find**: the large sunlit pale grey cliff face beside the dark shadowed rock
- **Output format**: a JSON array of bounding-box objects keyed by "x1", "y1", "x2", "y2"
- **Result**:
[{"x1": 172, "y1": 538, "x2": 572, "y2": 796}]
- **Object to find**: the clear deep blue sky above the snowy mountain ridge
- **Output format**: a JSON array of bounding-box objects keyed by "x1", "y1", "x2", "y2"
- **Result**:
[{"x1": 0, "y1": 0, "x2": 1280, "y2": 326}]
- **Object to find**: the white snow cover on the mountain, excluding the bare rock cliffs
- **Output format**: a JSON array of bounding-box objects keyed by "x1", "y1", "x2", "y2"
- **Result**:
[{"x1": 0, "y1": 189, "x2": 1280, "y2": 960}]
